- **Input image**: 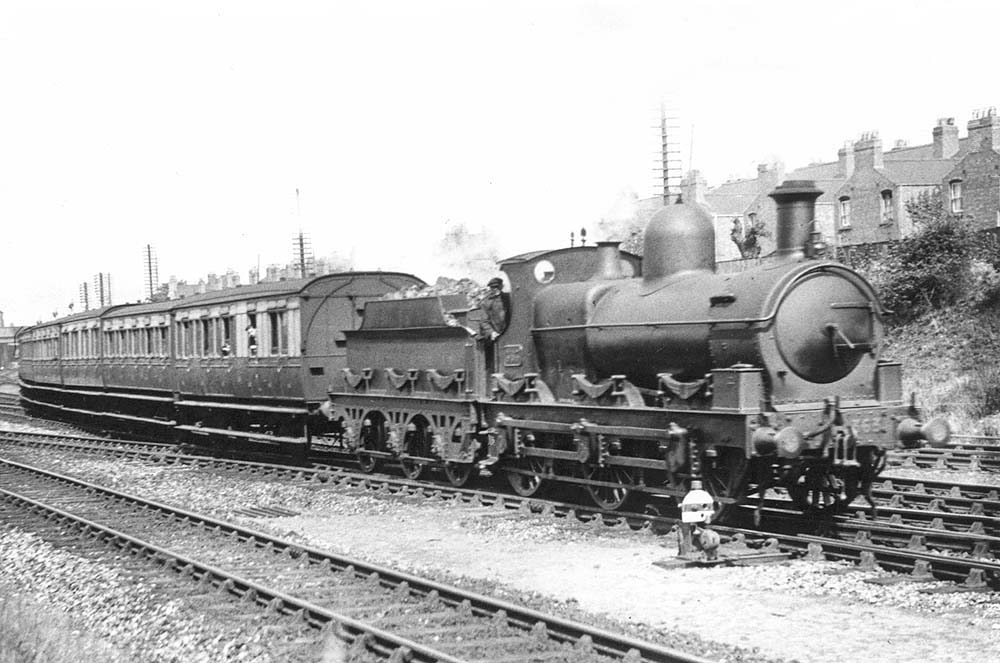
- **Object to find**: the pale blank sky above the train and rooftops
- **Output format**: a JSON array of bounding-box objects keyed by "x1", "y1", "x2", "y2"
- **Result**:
[{"x1": 0, "y1": 0, "x2": 1000, "y2": 325}]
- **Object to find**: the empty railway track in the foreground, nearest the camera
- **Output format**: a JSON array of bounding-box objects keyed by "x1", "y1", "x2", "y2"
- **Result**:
[{"x1": 0, "y1": 459, "x2": 720, "y2": 663}]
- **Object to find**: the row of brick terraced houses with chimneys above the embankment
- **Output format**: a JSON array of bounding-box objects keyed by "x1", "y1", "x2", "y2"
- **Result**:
[{"x1": 668, "y1": 108, "x2": 1000, "y2": 261}]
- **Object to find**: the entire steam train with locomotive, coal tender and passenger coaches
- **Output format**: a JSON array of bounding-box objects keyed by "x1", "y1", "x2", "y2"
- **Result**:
[{"x1": 19, "y1": 181, "x2": 950, "y2": 516}]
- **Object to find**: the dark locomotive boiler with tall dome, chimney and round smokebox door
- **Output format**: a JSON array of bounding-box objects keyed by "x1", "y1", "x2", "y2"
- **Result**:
[{"x1": 533, "y1": 182, "x2": 887, "y2": 406}]
